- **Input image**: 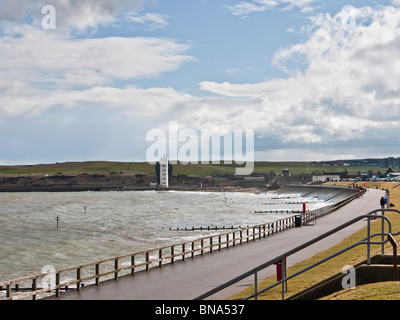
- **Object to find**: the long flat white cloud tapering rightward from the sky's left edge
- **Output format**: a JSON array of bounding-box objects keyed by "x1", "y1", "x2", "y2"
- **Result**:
[{"x1": 0, "y1": 25, "x2": 192, "y2": 112}]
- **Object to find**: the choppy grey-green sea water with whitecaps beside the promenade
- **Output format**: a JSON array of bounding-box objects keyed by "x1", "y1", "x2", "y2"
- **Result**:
[{"x1": 0, "y1": 191, "x2": 340, "y2": 281}]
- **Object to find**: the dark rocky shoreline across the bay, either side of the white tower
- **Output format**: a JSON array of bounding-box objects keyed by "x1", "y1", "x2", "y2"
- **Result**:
[{"x1": 0, "y1": 172, "x2": 266, "y2": 192}]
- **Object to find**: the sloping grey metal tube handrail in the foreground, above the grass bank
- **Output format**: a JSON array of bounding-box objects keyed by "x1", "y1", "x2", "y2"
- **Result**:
[{"x1": 194, "y1": 209, "x2": 400, "y2": 300}]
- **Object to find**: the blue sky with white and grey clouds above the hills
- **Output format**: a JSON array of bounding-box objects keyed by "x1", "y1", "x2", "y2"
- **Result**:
[{"x1": 0, "y1": 0, "x2": 400, "y2": 164}]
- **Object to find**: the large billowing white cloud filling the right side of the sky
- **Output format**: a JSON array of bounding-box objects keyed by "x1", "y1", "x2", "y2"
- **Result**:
[{"x1": 200, "y1": 7, "x2": 400, "y2": 145}]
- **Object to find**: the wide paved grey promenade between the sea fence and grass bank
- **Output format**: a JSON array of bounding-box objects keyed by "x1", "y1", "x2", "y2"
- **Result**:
[{"x1": 53, "y1": 189, "x2": 383, "y2": 300}]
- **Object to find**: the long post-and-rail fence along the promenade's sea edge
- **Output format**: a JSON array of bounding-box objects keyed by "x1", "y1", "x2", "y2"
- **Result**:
[{"x1": 0, "y1": 188, "x2": 359, "y2": 300}]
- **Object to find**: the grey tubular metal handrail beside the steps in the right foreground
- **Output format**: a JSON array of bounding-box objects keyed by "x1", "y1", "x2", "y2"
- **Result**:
[{"x1": 195, "y1": 209, "x2": 400, "y2": 300}]
